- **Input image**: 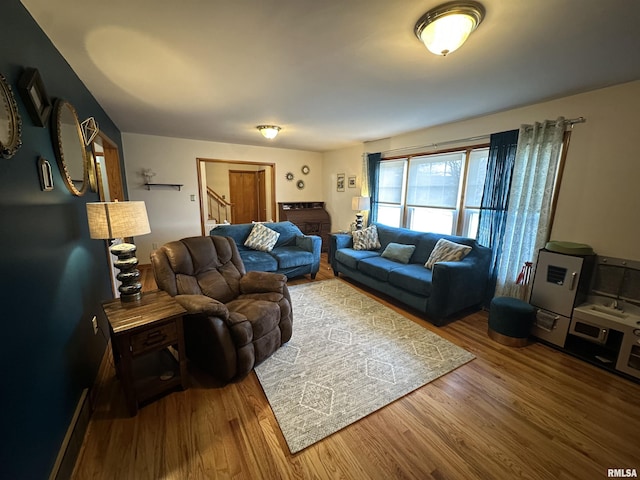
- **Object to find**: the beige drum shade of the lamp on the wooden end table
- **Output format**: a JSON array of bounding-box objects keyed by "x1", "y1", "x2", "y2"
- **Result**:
[{"x1": 87, "y1": 202, "x2": 151, "y2": 240}]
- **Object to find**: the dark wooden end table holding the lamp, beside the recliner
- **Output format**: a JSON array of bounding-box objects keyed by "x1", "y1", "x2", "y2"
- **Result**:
[{"x1": 102, "y1": 290, "x2": 189, "y2": 416}]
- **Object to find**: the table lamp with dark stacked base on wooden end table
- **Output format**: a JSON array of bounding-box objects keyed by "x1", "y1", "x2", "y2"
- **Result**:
[{"x1": 87, "y1": 201, "x2": 151, "y2": 303}]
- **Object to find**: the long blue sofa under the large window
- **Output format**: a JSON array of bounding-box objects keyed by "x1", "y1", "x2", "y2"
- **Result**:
[{"x1": 329, "y1": 224, "x2": 491, "y2": 326}]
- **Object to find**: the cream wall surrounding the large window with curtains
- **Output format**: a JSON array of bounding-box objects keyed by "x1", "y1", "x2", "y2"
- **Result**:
[{"x1": 324, "y1": 81, "x2": 640, "y2": 260}]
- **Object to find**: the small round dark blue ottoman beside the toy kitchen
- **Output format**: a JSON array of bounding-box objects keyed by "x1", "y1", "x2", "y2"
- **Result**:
[{"x1": 488, "y1": 297, "x2": 536, "y2": 347}]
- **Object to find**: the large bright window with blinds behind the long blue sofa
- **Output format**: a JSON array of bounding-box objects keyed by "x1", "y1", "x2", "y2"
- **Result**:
[{"x1": 378, "y1": 147, "x2": 489, "y2": 238}]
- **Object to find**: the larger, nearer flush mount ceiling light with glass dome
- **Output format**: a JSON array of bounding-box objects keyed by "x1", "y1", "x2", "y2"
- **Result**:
[{"x1": 414, "y1": 2, "x2": 485, "y2": 57}]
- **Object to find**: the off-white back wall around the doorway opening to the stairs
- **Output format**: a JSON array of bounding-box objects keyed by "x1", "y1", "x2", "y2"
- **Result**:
[{"x1": 122, "y1": 133, "x2": 323, "y2": 264}]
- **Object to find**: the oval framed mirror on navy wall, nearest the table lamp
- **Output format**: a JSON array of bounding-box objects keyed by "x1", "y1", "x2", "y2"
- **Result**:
[{"x1": 52, "y1": 100, "x2": 89, "y2": 196}]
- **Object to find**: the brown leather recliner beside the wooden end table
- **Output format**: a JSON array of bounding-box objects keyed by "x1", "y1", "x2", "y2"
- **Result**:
[{"x1": 151, "y1": 236, "x2": 293, "y2": 382}]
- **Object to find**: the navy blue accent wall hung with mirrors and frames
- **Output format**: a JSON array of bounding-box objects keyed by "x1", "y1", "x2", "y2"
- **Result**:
[{"x1": 0, "y1": 0, "x2": 124, "y2": 479}]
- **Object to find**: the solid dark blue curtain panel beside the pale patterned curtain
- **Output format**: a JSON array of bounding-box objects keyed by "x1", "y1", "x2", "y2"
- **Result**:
[{"x1": 477, "y1": 130, "x2": 518, "y2": 305}]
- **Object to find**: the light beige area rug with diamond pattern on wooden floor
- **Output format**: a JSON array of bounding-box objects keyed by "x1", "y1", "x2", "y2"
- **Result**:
[{"x1": 255, "y1": 279, "x2": 475, "y2": 453}]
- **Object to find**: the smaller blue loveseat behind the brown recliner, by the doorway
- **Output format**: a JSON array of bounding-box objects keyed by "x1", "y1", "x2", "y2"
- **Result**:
[{"x1": 209, "y1": 222, "x2": 322, "y2": 278}]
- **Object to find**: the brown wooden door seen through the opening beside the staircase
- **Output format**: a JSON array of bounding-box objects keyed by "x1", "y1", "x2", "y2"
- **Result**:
[{"x1": 229, "y1": 170, "x2": 266, "y2": 223}]
